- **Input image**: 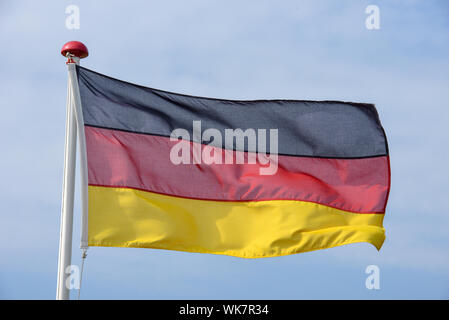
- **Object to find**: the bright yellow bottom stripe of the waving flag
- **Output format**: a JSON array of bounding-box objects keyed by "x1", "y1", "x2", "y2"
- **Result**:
[{"x1": 89, "y1": 186, "x2": 385, "y2": 258}]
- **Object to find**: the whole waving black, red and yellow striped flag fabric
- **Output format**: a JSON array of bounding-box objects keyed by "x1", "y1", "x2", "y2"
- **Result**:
[{"x1": 77, "y1": 66, "x2": 390, "y2": 258}]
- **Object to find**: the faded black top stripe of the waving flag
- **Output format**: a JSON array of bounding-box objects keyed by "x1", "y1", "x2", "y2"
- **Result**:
[{"x1": 77, "y1": 67, "x2": 388, "y2": 159}]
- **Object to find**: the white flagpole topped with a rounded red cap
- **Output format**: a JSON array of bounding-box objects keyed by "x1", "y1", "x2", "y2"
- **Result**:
[{"x1": 56, "y1": 41, "x2": 88, "y2": 300}]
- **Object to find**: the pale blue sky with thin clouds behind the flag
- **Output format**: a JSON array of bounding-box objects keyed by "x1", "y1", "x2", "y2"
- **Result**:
[{"x1": 0, "y1": 0, "x2": 449, "y2": 299}]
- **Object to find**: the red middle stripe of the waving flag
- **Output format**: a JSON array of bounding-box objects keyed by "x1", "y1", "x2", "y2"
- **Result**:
[{"x1": 85, "y1": 127, "x2": 389, "y2": 213}]
